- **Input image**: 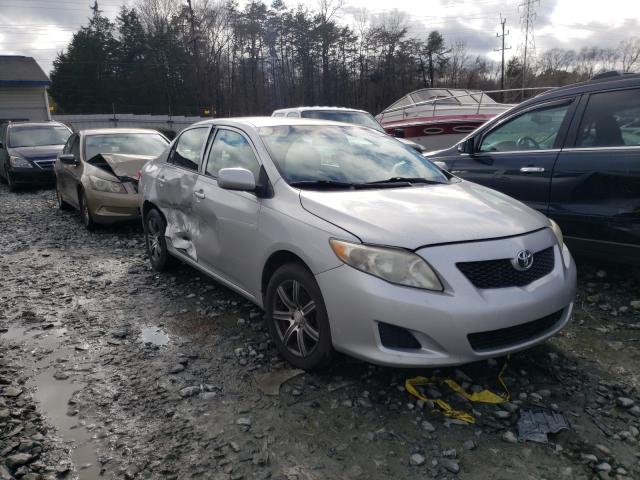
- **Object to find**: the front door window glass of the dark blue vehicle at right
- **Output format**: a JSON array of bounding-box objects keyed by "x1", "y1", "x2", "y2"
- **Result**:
[{"x1": 480, "y1": 103, "x2": 570, "y2": 152}]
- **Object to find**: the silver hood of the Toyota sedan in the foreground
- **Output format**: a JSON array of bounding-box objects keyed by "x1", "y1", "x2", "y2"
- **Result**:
[{"x1": 300, "y1": 181, "x2": 548, "y2": 250}]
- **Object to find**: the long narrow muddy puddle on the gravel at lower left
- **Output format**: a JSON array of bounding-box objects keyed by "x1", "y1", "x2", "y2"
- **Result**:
[{"x1": 0, "y1": 324, "x2": 100, "y2": 480}]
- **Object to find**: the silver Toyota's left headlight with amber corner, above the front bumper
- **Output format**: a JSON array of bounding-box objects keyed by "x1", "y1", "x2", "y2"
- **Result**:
[{"x1": 329, "y1": 239, "x2": 443, "y2": 292}]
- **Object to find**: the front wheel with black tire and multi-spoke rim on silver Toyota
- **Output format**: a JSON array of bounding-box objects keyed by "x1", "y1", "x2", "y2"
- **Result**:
[{"x1": 264, "y1": 263, "x2": 333, "y2": 370}]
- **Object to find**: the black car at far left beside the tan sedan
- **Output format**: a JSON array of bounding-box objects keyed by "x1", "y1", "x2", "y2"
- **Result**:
[{"x1": 0, "y1": 122, "x2": 72, "y2": 191}]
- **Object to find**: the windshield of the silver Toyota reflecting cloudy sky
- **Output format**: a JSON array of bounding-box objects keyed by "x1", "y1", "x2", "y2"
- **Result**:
[{"x1": 259, "y1": 125, "x2": 448, "y2": 187}]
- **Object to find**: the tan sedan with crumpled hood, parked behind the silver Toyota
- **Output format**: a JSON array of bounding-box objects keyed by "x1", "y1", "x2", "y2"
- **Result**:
[{"x1": 54, "y1": 128, "x2": 169, "y2": 230}]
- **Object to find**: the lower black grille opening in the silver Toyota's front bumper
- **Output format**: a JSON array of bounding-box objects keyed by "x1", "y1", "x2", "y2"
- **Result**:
[{"x1": 467, "y1": 310, "x2": 563, "y2": 352}]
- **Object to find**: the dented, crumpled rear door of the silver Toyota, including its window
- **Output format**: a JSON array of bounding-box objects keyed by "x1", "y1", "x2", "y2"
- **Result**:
[{"x1": 156, "y1": 126, "x2": 210, "y2": 260}]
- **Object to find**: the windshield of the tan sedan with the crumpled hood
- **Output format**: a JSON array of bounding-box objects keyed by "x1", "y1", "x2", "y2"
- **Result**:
[{"x1": 85, "y1": 133, "x2": 168, "y2": 160}]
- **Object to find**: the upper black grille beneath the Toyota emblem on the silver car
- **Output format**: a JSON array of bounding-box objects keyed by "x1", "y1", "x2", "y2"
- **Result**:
[{"x1": 456, "y1": 247, "x2": 555, "y2": 288}]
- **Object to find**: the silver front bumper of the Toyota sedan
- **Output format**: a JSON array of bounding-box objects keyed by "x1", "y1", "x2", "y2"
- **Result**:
[{"x1": 316, "y1": 229, "x2": 576, "y2": 367}]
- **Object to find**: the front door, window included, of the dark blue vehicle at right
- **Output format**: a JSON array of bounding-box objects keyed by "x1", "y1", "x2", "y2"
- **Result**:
[{"x1": 451, "y1": 98, "x2": 576, "y2": 213}]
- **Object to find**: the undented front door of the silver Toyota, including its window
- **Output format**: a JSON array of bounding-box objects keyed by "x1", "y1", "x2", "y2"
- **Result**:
[{"x1": 194, "y1": 128, "x2": 260, "y2": 293}]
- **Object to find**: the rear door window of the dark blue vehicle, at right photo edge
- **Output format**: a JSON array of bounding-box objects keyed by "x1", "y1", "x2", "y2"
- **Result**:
[{"x1": 576, "y1": 89, "x2": 640, "y2": 147}]
